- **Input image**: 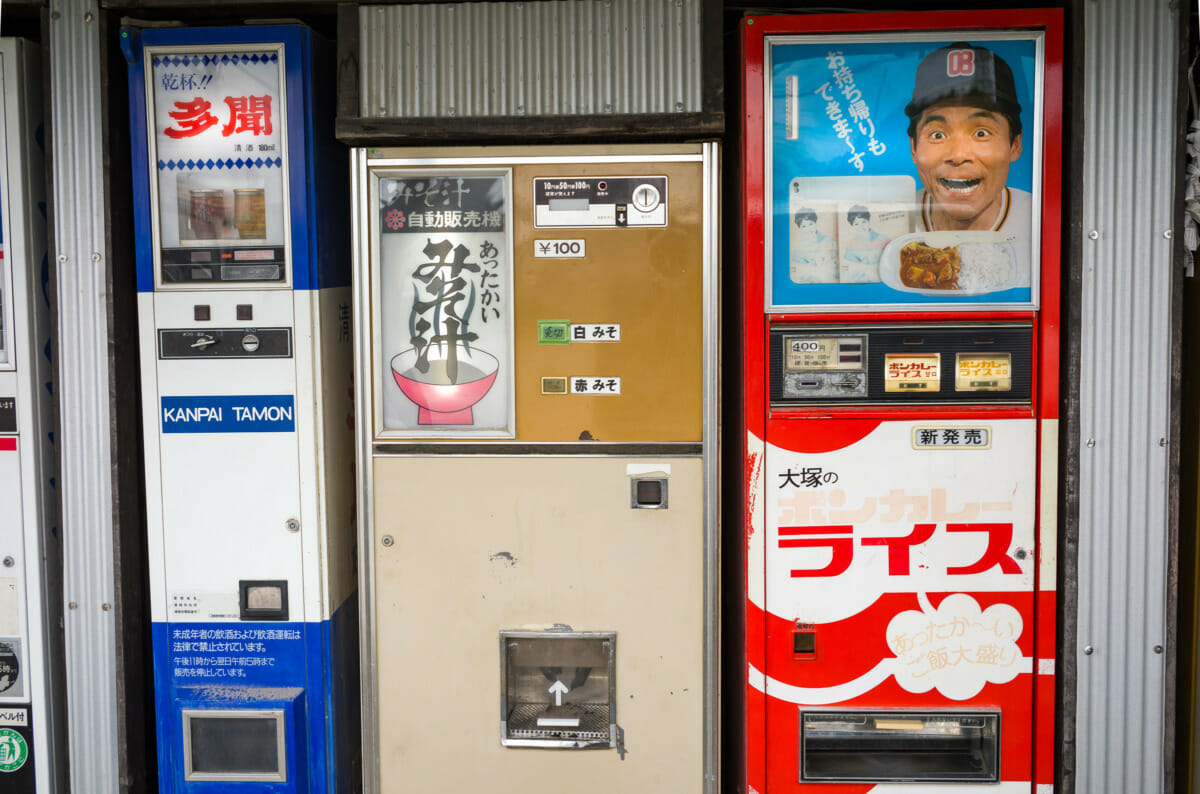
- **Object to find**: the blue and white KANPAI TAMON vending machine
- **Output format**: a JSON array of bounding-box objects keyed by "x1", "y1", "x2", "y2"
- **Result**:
[{"x1": 121, "y1": 25, "x2": 360, "y2": 794}]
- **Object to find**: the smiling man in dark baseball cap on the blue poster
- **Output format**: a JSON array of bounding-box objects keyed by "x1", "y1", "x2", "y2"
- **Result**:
[{"x1": 905, "y1": 42, "x2": 1032, "y2": 241}]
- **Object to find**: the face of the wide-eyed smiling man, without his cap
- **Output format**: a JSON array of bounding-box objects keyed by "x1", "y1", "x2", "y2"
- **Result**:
[{"x1": 910, "y1": 104, "x2": 1021, "y2": 230}]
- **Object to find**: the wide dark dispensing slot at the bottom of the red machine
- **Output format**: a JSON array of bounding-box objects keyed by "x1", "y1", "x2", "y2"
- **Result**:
[{"x1": 799, "y1": 711, "x2": 1000, "y2": 783}]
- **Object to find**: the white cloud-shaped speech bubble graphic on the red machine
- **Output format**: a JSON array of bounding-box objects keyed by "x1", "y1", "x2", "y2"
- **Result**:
[{"x1": 887, "y1": 593, "x2": 1024, "y2": 700}]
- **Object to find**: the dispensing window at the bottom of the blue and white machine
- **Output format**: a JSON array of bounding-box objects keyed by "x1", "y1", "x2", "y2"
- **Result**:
[{"x1": 182, "y1": 709, "x2": 288, "y2": 783}]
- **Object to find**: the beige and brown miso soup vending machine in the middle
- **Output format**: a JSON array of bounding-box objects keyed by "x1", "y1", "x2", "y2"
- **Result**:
[{"x1": 354, "y1": 144, "x2": 718, "y2": 794}]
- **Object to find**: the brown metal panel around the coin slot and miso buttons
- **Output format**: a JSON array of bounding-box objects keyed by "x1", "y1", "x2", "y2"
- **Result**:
[{"x1": 512, "y1": 162, "x2": 703, "y2": 441}]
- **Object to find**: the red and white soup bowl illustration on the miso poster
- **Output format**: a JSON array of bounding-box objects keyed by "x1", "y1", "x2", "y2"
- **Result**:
[{"x1": 391, "y1": 344, "x2": 500, "y2": 425}]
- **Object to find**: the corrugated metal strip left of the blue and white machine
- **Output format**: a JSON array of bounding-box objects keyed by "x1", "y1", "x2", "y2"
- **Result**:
[{"x1": 50, "y1": 0, "x2": 120, "y2": 794}]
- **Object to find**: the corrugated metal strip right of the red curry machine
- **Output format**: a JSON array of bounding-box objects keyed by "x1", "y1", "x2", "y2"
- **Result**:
[{"x1": 1067, "y1": 0, "x2": 1181, "y2": 794}]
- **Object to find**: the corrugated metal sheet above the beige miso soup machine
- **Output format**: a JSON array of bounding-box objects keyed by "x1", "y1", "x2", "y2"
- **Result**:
[{"x1": 359, "y1": 0, "x2": 701, "y2": 118}]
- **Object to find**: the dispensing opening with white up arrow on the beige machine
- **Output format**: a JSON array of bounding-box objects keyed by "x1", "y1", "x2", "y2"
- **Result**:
[{"x1": 500, "y1": 631, "x2": 617, "y2": 750}]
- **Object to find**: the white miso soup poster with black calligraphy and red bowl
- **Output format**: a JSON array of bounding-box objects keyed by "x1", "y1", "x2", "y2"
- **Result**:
[{"x1": 377, "y1": 170, "x2": 515, "y2": 438}]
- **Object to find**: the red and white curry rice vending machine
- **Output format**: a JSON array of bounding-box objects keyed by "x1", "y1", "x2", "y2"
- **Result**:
[{"x1": 742, "y1": 11, "x2": 1062, "y2": 794}]
